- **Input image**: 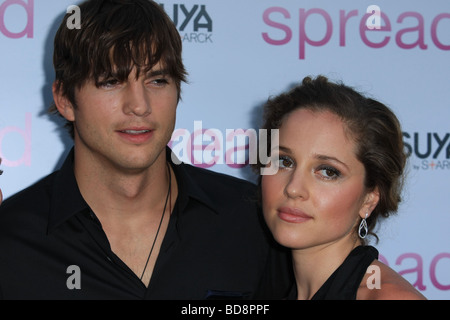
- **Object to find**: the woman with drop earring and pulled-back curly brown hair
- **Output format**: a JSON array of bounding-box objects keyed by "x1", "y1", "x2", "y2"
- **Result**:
[{"x1": 261, "y1": 76, "x2": 425, "y2": 300}]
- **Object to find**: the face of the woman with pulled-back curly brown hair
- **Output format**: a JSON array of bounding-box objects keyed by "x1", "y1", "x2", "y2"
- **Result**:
[{"x1": 262, "y1": 109, "x2": 378, "y2": 249}]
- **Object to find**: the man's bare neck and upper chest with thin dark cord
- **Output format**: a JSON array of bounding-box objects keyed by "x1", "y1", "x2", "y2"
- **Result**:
[{"x1": 75, "y1": 147, "x2": 178, "y2": 286}]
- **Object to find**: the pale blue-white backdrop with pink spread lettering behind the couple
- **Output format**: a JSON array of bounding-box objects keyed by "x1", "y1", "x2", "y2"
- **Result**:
[{"x1": 0, "y1": 0, "x2": 450, "y2": 299}]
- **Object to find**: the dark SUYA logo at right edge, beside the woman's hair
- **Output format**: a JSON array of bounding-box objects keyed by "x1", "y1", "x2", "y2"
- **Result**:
[{"x1": 403, "y1": 132, "x2": 450, "y2": 171}]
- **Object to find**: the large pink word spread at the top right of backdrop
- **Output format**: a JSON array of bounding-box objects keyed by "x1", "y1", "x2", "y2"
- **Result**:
[{"x1": 262, "y1": 5, "x2": 450, "y2": 60}]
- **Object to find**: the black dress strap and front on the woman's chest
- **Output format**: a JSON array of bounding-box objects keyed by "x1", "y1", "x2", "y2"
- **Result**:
[{"x1": 288, "y1": 246, "x2": 378, "y2": 300}]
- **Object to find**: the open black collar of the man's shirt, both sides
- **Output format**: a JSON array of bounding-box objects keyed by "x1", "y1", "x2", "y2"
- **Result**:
[{"x1": 48, "y1": 147, "x2": 218, "y2": 233}]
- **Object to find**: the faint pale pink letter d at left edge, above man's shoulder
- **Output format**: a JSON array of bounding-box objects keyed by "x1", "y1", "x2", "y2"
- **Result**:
[{"x1": 0, "y1": 112, "x2": 31, "y2": 167}]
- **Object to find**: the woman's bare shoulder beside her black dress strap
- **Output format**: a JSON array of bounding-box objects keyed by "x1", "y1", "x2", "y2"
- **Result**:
[{"x1": 356, "y1": 260, "x2": 426, "y2": 300}]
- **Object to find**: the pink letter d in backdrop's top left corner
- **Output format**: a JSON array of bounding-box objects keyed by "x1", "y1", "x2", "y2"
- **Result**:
[{"x1": 0, "y1": 0, "x2": 34, "y2": 39}]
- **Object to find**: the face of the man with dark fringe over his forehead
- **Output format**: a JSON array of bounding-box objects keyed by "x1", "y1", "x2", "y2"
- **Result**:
[{"x1": 58, "y1": 64, "x2": 178, "y2": 173}]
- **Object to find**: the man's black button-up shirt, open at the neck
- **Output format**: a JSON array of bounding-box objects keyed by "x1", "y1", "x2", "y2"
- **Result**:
[{"x1": 0, "y1": 149, "x2": 292, "y2": 299}]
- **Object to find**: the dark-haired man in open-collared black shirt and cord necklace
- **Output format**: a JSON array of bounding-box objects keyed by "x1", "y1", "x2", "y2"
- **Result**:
[{"x1": 0, "y1": 0, "x2": 290, "y2": 299}]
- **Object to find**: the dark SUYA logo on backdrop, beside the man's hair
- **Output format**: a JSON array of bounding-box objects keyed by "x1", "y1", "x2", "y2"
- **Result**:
[{"x1": 160, "y1": 4, "x2": 213, "y2": 43}]
